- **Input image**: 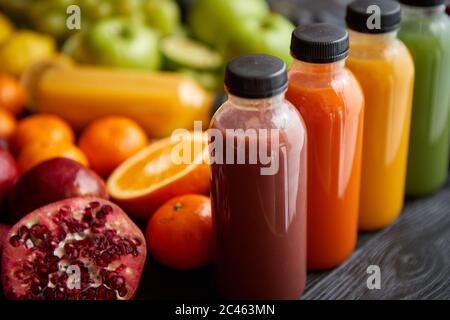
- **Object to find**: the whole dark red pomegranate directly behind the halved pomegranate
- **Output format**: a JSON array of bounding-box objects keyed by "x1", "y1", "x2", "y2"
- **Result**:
[{"x1": 9, "y1": 158, "x2": 108, "y2": 222}]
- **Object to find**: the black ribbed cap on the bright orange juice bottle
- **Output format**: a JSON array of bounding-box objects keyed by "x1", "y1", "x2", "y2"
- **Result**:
[{"x1": 291, "y1": 23, "x2": 349, "y2": 63}]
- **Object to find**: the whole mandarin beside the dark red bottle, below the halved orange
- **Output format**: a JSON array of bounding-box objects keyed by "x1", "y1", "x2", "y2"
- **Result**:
[{"x1": 145, "y1": 194, "x2": 213, "y2": 270}]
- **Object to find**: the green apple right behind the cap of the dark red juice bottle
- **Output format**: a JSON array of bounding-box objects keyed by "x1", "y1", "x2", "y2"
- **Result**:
[{"x1": 219, "y1": 13, "x2": 294, "y2": 65}]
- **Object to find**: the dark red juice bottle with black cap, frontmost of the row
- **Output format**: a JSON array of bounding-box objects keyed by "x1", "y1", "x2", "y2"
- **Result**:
[{"x1": 209, "y1": 55, "x2": 307, "y2": 299}]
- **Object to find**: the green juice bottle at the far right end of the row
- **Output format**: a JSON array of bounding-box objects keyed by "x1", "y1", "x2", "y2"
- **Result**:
[{"x1": 399, "y1": 0, "x2": 450, "y2": 196}]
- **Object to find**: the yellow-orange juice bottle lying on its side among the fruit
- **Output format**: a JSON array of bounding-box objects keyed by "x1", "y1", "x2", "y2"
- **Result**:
[{"x1": 23, "y1": 61, "x2": 213, "y2": 138}]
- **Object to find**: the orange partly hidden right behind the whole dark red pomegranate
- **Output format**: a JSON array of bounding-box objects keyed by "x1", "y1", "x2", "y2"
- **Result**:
[{"x1": 18, "y1": 141, "x2": 88, "y2": 172}]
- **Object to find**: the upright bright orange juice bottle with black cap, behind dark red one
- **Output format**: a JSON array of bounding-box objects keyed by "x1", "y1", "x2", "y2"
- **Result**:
[{"x1": 287, "y1": 24, "x2": 364, "y2": 269}]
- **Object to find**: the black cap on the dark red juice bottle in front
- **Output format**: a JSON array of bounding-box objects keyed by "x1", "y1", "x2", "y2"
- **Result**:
[{"x1": 225, "y1": 54, "x2": 288, "y2": 99}]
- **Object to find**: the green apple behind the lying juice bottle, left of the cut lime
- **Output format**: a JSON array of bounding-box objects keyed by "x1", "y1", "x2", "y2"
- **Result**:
[{"x1": 86, "y1": 17, "x2": 161, "y2": 70}]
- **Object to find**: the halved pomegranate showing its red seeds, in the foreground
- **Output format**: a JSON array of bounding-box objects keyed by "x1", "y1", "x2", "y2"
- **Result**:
[{"x1": 2, "y1": 197, "x2": 147, "y2": 300}]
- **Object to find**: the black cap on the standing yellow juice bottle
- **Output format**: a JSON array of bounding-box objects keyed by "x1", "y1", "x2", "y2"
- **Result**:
[{"x1": 346, "y1": 0, "x2": 401, "y2": 33}]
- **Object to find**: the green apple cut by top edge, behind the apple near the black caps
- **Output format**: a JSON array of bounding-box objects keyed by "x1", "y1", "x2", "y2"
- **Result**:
[{"x1": 188, "y1": 0, "x2": 270, "y2": 46}]
